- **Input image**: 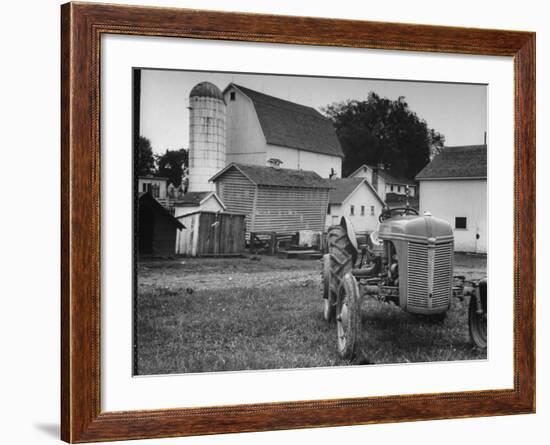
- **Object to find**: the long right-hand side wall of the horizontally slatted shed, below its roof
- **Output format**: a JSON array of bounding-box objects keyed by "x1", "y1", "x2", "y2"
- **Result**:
[{"x1": 252, "y1": 187, "x2": 328, "y2": 234}]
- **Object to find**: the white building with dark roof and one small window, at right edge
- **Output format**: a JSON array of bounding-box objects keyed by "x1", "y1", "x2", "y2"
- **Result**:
[{"x1": 416, "y1": 145, "x2": 487, "y2": 253}]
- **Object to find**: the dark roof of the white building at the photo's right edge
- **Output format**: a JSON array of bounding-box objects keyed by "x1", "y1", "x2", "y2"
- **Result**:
[{"x1": 416, "y1": 145, "x2": 487, "y2": 180}]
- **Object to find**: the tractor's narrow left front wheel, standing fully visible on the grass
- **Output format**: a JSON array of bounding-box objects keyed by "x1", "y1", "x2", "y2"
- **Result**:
[{"x1": 336, "y1": 273, "x2": 361, "y2": 360}]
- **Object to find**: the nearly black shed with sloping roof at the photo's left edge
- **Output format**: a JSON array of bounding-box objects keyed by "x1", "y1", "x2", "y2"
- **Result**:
[{"x1": 137, "y1": 192, "x2": 185, "y2": 257}]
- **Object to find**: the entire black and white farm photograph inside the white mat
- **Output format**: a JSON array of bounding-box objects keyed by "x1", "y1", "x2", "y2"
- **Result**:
[{"x1": 132, "y1": 68, "x2": 489, "y2": 375}]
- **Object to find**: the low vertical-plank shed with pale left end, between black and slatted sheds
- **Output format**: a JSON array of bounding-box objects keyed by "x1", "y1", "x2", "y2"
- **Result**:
[{"x1": 176, "y1": 210, "x2": 245, "y2": 256}]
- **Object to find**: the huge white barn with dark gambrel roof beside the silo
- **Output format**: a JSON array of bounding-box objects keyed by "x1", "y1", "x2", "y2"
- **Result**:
[{"x1": 223, "y1": 83, "x2": 344, "y2": 178}]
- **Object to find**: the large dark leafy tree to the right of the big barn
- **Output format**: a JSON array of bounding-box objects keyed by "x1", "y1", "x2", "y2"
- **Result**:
[{"x1": 322, "y1": 92, "x2": 445, "y2": 178}]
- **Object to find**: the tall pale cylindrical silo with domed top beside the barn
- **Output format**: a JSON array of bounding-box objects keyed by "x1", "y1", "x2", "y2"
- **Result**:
[{"x1": 188, "y1": 82, "x2": 226, "y2": 192}]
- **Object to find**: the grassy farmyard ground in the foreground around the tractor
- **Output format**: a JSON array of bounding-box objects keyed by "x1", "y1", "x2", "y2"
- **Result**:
[{"x1": 136, "y1": 254, "x2": 486, "y2": 375}]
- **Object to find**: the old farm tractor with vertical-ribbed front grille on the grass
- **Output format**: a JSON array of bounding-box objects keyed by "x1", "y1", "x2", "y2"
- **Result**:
[{"x1": 322, "y1": 205, "x2": 487, "y2": 360}]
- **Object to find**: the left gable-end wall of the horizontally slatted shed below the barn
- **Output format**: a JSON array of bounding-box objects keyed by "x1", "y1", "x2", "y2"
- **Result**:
[{"x1": 216, "y1": 168, "x2": 256, "y2": 233}]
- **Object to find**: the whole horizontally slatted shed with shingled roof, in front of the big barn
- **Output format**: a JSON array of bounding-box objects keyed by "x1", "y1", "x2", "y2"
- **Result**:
[{"x1": 211, "y1": 163, "x2": 331, "y2": 237}]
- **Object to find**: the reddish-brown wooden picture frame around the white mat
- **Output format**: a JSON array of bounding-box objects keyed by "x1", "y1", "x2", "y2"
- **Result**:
[{"x1": 61, "y1": 3, "x2": 535, "y2": 443}]
